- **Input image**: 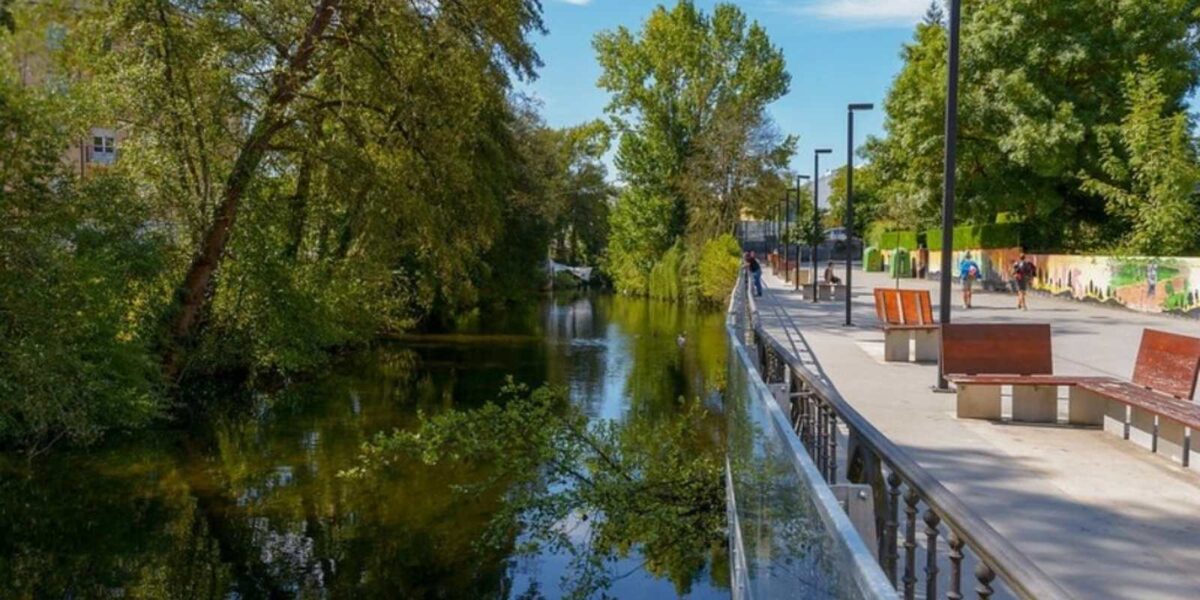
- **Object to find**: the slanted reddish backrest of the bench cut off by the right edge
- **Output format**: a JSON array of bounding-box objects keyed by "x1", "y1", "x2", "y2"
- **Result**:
[{"x1": 1133, "y1": 329, "x2": 1200, "y2": 400}]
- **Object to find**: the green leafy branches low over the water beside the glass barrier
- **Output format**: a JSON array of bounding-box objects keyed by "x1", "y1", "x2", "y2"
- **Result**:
[{"x1": 350, "y1": 386, "x2": 725, "y2": 596}]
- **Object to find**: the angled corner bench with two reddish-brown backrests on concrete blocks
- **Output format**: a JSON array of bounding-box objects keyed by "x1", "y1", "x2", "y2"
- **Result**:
[{"x1": 942, "y1": 324, "x2": 1200, "y2": 466}]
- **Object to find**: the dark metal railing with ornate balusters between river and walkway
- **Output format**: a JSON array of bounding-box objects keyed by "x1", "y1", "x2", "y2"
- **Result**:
[{"x1": 730, "y1": 275, "x2": 1070, "y2": 600}]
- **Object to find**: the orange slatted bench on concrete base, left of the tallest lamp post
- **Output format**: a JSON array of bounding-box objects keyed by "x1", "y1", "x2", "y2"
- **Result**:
[{"x1": 875, "y1": 288, "x2": 938, "y2": 362}]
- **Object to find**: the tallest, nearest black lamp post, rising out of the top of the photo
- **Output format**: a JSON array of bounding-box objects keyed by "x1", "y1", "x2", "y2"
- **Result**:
[{"x1": 935, "y1": 0, "x2": 962, "y2": 391}]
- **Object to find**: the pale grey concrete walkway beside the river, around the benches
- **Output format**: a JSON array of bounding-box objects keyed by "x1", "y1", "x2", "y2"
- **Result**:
[{"x1": 760, "y1": 269, "x2": 1200, "y2": 600}]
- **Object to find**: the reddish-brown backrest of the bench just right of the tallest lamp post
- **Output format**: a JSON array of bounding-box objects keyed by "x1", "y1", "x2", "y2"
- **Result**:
[{"x1": 941, "y1": 323, "x2": 1054, "y2": 374}]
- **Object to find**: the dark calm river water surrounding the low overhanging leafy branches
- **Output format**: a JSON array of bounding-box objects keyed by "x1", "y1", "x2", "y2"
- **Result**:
[{"x1": 0, "y1": 295, "x2": 728, "y2": 599}]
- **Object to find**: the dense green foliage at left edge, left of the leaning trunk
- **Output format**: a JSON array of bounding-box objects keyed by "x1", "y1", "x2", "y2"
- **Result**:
[{"x1": 0, "y1": 77, "x2": 166, "y2": 452}]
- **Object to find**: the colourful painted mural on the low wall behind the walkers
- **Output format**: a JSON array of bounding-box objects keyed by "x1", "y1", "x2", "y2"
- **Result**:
[{"x1": 929, "y1": 248, "x2": 1200, "y2": 318}]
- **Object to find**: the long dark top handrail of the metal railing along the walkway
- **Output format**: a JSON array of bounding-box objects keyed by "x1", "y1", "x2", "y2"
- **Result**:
[{"x1": 739, "y1": 288, "x2": 1072, "y2": 600}]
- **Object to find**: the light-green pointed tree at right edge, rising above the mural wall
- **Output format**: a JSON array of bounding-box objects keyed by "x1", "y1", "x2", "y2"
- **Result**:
[{"x1": 1084, "y1": 60, "x2": 1200, "y2": 256}]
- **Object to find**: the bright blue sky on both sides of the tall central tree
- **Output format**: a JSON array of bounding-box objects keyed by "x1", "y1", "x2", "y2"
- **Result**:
[{"x1": 526, "y1": 0, "x2": 929, "y2": 180}]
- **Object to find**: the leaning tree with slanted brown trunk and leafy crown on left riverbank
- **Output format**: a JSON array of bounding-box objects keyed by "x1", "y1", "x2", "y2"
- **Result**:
[{"x1": 76, "y1": 0, "x2": 541, "y2": 380}]
